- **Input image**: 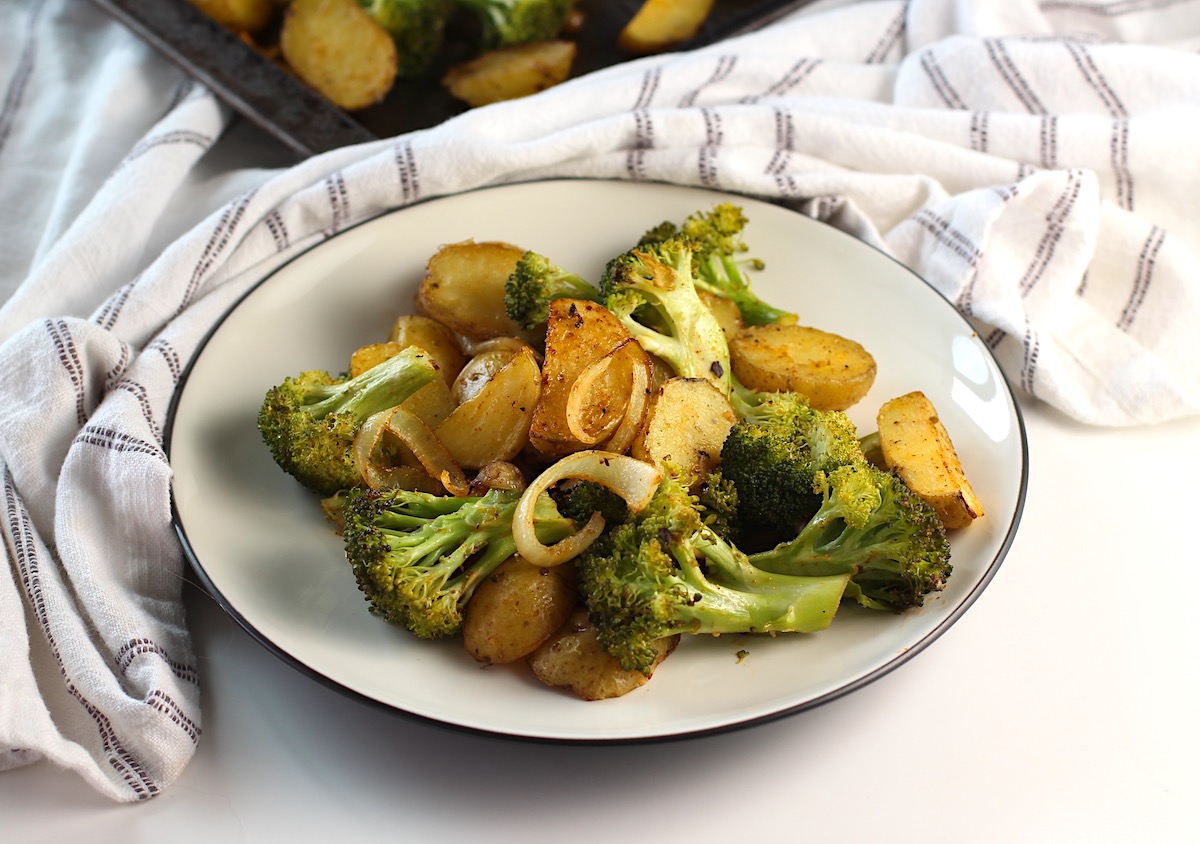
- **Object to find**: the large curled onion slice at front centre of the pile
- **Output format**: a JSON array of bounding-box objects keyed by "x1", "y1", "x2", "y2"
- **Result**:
[{"x1": 512, "y1": 450, "x2": 662, "y2": 565}]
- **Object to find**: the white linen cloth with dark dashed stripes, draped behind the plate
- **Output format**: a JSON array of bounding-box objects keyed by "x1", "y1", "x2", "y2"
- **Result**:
[{"x1": 0, "y1": 0, "x2": 1200, "y2": 801}]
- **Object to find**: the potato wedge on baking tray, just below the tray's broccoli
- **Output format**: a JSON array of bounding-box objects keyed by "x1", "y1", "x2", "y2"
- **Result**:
[{"x1": 442, "y1": 40, "x2": 576, "y2": 107}]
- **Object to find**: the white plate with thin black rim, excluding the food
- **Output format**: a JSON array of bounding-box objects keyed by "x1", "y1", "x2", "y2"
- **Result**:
[{"x1": 168, "y1": 181, "x2": 1027, "y2": 742}]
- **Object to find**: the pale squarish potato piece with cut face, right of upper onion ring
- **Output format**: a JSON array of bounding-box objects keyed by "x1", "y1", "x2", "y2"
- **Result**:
[{"x1": 630, "y1": 377, "x2": 738, "y2": 489}]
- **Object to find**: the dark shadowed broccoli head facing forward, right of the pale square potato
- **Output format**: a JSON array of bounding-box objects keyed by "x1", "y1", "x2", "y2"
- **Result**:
[{"x1": 720, "y1": 393, "x2": 865, "y2": 550}]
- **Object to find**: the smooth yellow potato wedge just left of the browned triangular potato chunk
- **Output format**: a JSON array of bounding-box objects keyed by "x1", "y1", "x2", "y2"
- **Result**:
[{"x1": 433, "y1": 347, "x2": 541, "y2": 469}]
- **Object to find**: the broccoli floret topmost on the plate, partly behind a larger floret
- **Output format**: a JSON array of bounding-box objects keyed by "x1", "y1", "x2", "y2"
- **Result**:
[{"x1": 641, "y1": 202, "x2": 796, "y2": 325}]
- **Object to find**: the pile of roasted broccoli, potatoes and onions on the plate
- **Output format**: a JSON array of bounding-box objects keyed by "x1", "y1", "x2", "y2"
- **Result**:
[{"x1": 258, "y1": 203, "x2": 983, "y2": 700}]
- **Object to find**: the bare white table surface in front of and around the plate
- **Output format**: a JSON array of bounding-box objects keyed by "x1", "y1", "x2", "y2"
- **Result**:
[{"x1": 0, "y1": 399, "x2": 1200, "y2": 844}]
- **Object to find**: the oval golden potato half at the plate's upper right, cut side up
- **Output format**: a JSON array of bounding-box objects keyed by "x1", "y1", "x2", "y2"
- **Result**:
[{"x1": 730, "y1": 325, "x2": 876, "y2": 411}]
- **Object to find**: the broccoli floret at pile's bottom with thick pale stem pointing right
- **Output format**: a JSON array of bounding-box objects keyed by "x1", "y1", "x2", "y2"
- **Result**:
[{"x1": 575, "y1": 477, "x2": 848, "y2": 674}]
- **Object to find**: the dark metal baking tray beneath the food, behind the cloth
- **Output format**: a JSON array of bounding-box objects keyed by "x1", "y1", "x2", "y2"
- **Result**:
[{"x1": 92, "y1": 0, "x2": 811, "y2": 158}]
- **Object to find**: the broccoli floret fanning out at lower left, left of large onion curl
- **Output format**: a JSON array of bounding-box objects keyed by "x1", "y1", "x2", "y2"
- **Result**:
[{"x1": 342, "y1": 489, "x2": 575, "y2": 639}]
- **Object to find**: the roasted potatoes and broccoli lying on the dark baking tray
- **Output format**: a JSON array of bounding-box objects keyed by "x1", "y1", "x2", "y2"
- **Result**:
[{"x1": 191, "y1": 0, "x2": 714, "y2": 110}]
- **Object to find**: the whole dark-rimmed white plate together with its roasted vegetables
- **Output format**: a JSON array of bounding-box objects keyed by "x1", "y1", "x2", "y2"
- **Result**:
[{"x1": 168, "y1": 180, "x2": 1027, "y2": 742}]
